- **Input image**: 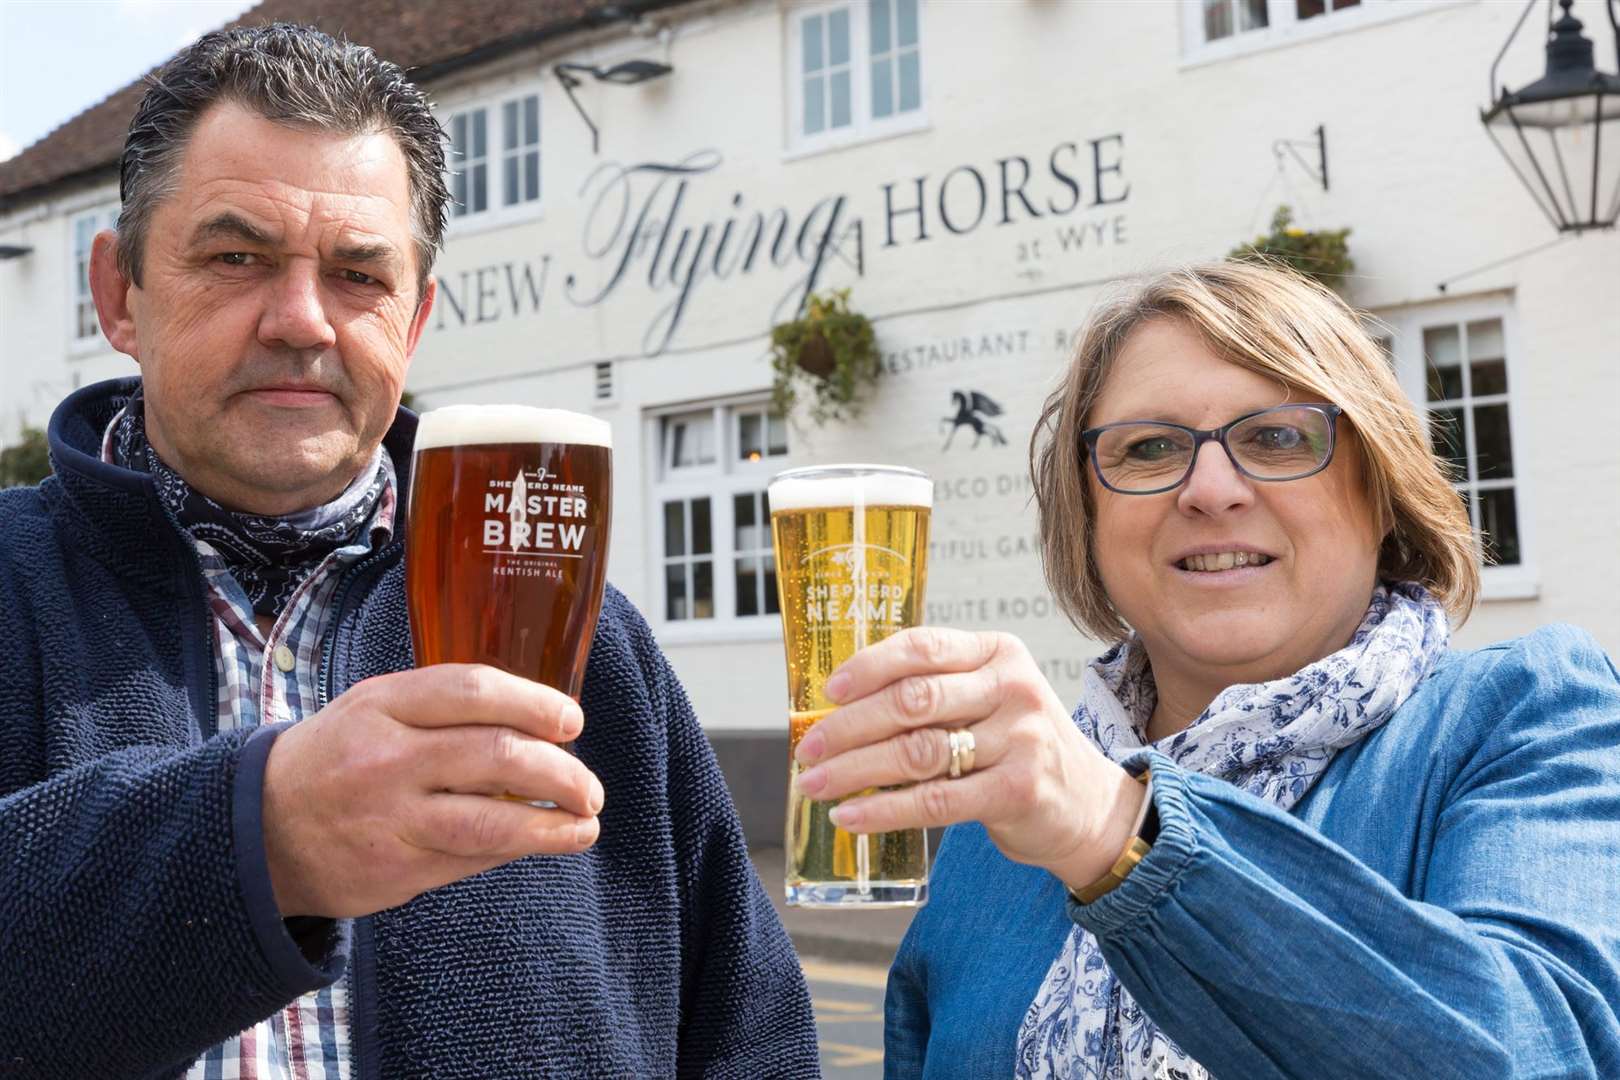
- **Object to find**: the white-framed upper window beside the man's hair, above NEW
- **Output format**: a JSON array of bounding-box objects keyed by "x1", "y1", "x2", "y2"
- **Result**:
[{"x1": 447, "y1": 94, "x2": 539, "y2": 220}]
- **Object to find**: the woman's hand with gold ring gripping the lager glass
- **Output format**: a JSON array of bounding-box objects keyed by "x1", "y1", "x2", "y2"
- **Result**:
[{"x1": 795, "y1": 627, "x2": 1144, "y2": 887}]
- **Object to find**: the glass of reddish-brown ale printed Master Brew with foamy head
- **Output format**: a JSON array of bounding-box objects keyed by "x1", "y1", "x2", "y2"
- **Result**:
[{"x1": 405, "y1": 405, "x2": 612, "y2": 699}]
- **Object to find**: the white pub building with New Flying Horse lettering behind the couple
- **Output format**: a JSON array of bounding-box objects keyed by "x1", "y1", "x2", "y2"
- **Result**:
[{"x1": 0, "y1": 0, "x2": 1620, "y2": 845}]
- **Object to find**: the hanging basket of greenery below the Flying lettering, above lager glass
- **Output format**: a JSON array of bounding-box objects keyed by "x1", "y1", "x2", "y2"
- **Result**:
[{"x1": 771, "y1": 288, "x2": 880, "y2": 424}]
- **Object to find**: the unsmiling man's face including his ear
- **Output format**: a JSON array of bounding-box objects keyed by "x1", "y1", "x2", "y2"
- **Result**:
[{"x1": 102, "y1": 104, "x2": 433, "y2": 515}]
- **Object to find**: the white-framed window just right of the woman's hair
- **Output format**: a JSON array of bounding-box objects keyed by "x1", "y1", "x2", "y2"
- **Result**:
[{"x1": 1380, "y1": 301, "x2": 1534, "y2": 599}]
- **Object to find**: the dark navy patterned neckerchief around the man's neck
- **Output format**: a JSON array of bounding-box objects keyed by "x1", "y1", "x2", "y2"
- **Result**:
[{"x1": 110, "y1": 389, "x2": 387, "y2": 617}]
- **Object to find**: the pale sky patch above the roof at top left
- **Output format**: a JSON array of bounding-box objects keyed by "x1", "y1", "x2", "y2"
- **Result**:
[{"x1": 0, "y1": 0, "x2": 258, "y2": 160}]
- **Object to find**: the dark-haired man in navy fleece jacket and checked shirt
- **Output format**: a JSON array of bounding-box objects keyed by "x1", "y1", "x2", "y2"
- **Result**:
[{"x1": 0, "y1": 26, "x2": 818, "y2": 1080}]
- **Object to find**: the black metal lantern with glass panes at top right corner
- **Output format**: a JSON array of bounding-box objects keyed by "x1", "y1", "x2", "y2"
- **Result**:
[{"x1": 1479, "y1": 0, "x2": 1620, "y2": 233}]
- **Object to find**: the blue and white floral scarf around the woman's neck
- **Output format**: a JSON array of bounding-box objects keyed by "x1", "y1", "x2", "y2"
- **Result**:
[{"x1": 1014, "y1": 585, "x2": 1450, "y2": 1080}]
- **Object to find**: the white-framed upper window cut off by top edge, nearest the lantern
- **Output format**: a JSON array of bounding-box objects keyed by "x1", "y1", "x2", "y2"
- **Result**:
[{"x1": 1181, "y1": 0, "x2": 1425, "y2": 60}]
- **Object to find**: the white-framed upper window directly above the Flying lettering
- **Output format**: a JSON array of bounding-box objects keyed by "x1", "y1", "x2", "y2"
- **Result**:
[{"x1": 787, "y1": 0, "x2": 923, "y2": 149}]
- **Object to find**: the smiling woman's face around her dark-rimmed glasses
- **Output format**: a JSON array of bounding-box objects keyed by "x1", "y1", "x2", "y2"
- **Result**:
[{"x1": 1087, "y1": 319, "x2": 1382, "y2": 687}]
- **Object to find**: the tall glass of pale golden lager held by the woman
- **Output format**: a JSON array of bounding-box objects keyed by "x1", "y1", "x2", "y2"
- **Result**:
[{"x1": 768, "y1": 465, "x2": 933, "y2": 907}]
